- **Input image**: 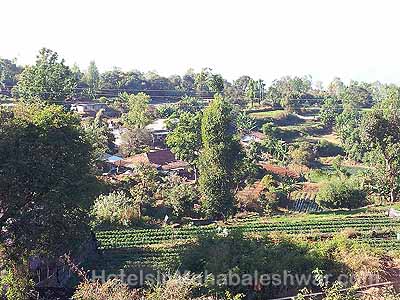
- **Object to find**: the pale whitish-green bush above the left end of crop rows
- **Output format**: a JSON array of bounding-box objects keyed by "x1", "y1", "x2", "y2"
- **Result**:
[{"x1": 92, "y1": 192, "x2": 137, "y2": 226}]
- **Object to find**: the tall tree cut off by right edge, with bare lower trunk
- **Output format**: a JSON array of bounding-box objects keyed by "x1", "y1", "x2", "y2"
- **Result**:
[{"x1": 361, "y1": 89, "x2": 400, "y2": 202}]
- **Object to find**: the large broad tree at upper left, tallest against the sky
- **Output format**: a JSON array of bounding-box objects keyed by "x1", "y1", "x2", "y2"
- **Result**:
[{"x1": 13, "y1": 48, "x2": 76, "y2": 103}]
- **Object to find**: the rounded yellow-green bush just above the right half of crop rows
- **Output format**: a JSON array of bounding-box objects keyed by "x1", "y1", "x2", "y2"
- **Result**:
[{"x1": 317, "y1": 180, "x2": 367, "y2": 209}]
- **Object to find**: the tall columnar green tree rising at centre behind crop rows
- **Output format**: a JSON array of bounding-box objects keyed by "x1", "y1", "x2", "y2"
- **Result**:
[{"x1": 199, "y1": 96, "x2": 240, "y2": 217}]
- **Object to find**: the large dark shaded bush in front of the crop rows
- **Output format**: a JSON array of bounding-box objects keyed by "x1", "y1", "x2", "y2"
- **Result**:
[{"x1": 179, "y1": 232, "x2": 347, "y2": 299}]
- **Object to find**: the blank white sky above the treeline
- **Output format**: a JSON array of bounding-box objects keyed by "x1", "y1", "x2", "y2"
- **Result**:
[{"x1": 0, "y1": 0, "x2": 400, "y2": 84}]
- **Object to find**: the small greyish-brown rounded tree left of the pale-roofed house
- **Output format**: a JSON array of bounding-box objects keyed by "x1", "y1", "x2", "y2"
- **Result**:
[{"x1": 120, "y1": 128, "x2": 153, "y2": 156}]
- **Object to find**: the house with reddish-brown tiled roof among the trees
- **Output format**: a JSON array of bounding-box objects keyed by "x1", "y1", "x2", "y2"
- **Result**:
[{"x1": 120, "y1": 149, "x2": 189, "y2": 177}]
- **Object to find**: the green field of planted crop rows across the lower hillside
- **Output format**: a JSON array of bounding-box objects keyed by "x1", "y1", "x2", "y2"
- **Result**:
[{"x1": 96, "y1": 213, "x2": 400, "y2": 270}]
